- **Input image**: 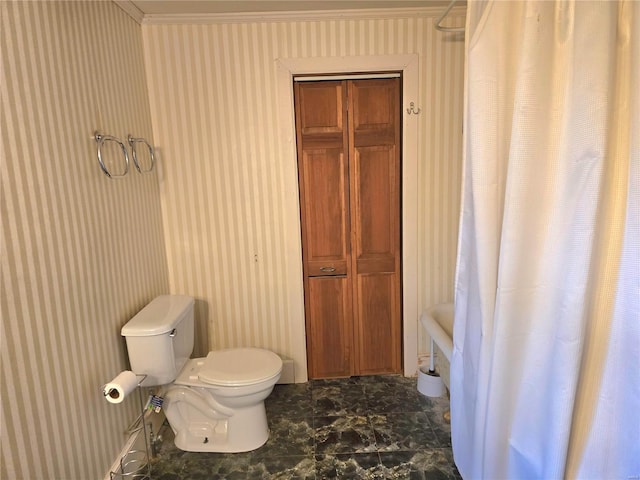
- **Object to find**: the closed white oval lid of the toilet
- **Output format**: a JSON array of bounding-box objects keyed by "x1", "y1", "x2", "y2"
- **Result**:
[{"x1": 198, "y1": 348, "x2": 282, "y2": 386}]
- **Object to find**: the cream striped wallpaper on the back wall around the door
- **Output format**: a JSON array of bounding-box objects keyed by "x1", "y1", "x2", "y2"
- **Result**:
[{"x1": 143, "y1": 8, "x2": 464, "y2": 379}]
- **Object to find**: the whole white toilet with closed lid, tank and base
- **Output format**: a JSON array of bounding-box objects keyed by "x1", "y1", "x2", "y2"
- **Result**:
[{"x1": 122, "y1": 295, "x2": 282, "y2": 453}]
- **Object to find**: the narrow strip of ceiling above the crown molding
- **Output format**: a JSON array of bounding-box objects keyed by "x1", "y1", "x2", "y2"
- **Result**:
[{"x1": 131, "y1": 0, "x2": 456, "y2": 15}]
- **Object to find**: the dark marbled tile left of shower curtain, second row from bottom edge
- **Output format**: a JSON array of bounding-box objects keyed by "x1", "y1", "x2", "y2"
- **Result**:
[{"x1": 369, "y1": 412, "x2": 441, "y2": 452}]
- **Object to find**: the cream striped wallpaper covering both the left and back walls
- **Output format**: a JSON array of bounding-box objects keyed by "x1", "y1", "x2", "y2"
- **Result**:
[{"x1": 0, "y1": 1, "x2": 463, "y2": 479}]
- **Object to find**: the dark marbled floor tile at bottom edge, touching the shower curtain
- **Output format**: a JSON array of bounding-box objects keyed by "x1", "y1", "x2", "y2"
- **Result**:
[{"x1": 380, "y1": 448, "x2": 461, "y2": 480}]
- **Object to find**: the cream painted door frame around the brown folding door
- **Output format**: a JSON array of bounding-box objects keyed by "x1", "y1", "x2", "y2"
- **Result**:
[{"x1": 276, "y1": 54, "x2": 420, "y2": 382}]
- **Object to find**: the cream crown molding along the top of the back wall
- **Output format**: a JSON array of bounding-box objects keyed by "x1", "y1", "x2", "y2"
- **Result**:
[{"x1": 139, "y1": 5, "x2": 466, "y2": 25}]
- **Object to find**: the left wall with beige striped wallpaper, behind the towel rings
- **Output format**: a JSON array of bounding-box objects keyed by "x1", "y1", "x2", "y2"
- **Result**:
[{"x1": 0, "y1": 2, "x2": 169, "y2": 479}]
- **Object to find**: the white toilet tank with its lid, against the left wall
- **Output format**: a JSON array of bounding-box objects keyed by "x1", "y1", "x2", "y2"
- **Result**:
[{"x1": 121, "y1": 295, "x2": 194, "y2": 387}]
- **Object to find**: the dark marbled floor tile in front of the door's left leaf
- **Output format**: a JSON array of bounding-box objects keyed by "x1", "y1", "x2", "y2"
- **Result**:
[{"x1": 311, "y1": 383, "x2": 368, "y2": 417}]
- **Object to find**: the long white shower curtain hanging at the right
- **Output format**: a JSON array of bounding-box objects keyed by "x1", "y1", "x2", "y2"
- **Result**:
[{"x1": 451, "y1": 0, "x2": 640, "y2": 480}]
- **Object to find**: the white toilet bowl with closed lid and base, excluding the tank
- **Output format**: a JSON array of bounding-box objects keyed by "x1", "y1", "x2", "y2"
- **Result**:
[{"x1": 164, "y1": 348, "x2": 282, "y2": 453}]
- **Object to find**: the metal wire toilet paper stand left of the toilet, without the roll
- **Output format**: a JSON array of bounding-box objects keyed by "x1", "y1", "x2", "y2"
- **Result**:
[{"x1": 102, "y1": 373, "x2": 151, "y2": 480}]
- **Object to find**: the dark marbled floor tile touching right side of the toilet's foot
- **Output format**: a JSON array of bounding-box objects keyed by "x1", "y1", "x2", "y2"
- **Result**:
[{"x1": 253, "y1": 412, "x2": 314, "y2": 458}]
